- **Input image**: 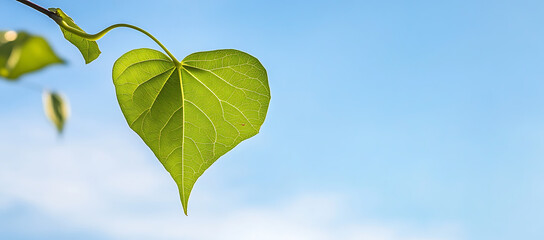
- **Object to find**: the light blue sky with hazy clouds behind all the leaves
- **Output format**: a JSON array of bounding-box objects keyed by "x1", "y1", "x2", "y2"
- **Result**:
[{"x1": 0, "y1": 0, "x2": 544, "y2": 240}]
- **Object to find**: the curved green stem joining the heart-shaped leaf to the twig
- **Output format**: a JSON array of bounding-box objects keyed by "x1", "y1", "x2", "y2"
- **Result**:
[{"x1": 55, "y1": 19, "x2": 181, "y2": 63}]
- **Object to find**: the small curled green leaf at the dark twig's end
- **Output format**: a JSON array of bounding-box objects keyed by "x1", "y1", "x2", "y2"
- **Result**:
[{"x1": 49, "y1": 8, "x2": 101, "y2": 64}]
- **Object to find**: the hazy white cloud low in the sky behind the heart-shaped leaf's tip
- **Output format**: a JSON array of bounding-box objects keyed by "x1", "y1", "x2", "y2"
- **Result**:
[{"x1": 0, "y1": 119, "x2": 461, "y2": 240}]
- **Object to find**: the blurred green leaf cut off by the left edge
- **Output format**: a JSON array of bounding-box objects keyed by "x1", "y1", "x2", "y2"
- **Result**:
[{"x1": 0, "y1": 31, "x2": 63, "y2": 80}]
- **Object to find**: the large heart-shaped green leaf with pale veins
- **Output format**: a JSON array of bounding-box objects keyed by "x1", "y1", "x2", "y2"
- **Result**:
[{"x1": 113, "y1": 49, "x2": 270, "y2": 214}]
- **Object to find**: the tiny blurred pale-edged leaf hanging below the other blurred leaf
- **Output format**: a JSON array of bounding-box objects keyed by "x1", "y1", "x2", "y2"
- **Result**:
[{"x1": 43, "y1": 91, "x2": 70, "y2": 134}]
